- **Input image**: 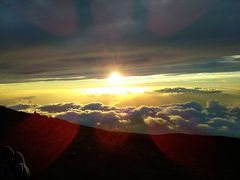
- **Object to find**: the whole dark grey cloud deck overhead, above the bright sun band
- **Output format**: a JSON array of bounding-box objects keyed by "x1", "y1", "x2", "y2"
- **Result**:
[{"x1": 0, "y1": 0, "x2": 240, "y2": 83}]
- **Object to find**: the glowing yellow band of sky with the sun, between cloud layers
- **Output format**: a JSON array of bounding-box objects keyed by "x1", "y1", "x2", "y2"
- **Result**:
[{"x1": 0, "y1": 72, "x2": 240, "y2": 106}]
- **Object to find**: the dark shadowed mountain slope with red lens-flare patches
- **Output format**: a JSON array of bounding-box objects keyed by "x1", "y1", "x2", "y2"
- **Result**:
[{"x1": 0, "y1": 107, "x2": 240, "y2": 179}]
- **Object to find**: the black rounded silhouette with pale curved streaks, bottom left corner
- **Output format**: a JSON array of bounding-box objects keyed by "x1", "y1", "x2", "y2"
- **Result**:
[{"x1": 0, "y1": 146, "x2": 30, "y2": 180}]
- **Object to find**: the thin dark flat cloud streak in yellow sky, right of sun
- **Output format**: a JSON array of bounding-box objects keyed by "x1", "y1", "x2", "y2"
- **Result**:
[{"x1": 154, "y1": 87, "x2": 223, "y2": 94}]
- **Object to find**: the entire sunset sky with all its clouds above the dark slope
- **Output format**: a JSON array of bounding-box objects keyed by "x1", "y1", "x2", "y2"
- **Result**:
[{"x1": 0, "y1": 0, "x2": 240, "y2": 137}]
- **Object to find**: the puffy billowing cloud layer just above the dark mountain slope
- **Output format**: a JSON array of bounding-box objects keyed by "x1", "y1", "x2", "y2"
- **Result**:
[{"x1": 7, "y1": 101, "x2": 240, "y2": 137}]
